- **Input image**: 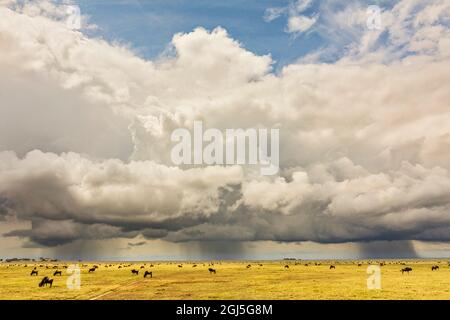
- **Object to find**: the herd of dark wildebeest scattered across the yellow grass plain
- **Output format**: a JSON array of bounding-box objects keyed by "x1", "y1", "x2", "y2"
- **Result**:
[{"x1": 1, "y1": 261, "x2": 450, "y2": 288}]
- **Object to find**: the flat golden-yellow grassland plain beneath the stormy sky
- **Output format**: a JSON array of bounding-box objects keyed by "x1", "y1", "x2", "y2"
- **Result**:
[{"x1": 0, "y1": 260, "x2": 450, "y2": 300}]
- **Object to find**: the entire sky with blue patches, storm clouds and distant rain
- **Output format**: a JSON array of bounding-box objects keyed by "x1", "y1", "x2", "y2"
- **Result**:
[{"x1": 0, "y1": 0, "x2": 450, "y2": 260}]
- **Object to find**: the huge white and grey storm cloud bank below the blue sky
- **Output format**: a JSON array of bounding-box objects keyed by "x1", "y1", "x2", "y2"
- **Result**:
[{"x1": 0, "y1": 0, "x2": 450, "y2": 246}]
